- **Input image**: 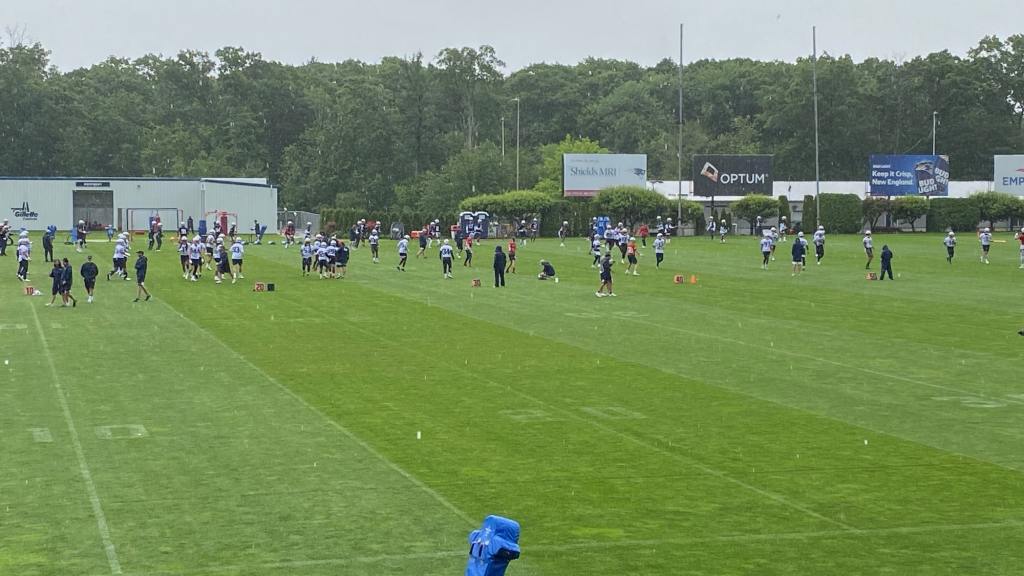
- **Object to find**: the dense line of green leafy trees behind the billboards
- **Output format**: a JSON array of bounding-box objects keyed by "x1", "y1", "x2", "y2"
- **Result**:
[{"x1": 0, "y1": 35, "x2": 1024, "y2": 212}]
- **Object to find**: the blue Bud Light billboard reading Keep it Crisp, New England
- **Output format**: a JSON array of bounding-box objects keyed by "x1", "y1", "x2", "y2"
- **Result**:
[{"x1": 869, "y1": 154, "x2": 949, "y2": 196}]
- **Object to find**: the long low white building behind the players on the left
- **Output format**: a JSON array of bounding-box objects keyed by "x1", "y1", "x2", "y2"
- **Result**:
[{"x1": 0, "y1": 177, "x2": 278, "y2": 232}]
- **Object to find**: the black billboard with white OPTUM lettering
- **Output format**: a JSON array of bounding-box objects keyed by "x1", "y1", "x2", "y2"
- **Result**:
[{"x1": 693, "y1": 154, "x2": 773, "y2": 196}]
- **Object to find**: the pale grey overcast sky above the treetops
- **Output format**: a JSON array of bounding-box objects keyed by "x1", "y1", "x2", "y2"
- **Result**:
[{"x1": 0, "y1": 0, "x2": 1024, "y2": 72}]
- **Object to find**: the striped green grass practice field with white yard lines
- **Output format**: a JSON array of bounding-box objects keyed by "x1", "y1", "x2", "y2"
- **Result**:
[{"x1": 0, "y1": 233, "x2": 1024, "y2": 576}]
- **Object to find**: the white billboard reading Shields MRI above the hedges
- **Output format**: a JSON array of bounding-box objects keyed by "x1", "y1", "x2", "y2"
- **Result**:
[{"x1": 562, "y1": 154, "x2": 647, "y2": 196}]
